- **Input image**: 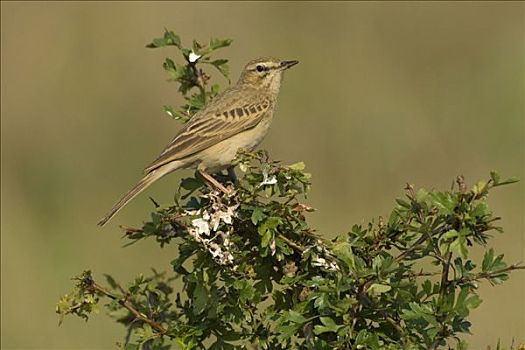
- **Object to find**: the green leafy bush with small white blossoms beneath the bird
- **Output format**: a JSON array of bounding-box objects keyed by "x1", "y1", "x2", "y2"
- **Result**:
[{"x1": 57, "y1": 31, "x2": 524, "y2": 349}]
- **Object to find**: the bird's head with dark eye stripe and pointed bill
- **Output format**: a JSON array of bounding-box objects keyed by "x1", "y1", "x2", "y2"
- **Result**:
[{"x1": 239, "y1": 57, "x2": 299, "y2": 94}]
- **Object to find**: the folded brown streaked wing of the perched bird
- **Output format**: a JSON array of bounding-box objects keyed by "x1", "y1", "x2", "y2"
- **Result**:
[{"x1": 144, "y1": 90, "x2": 273, "y2": 173}]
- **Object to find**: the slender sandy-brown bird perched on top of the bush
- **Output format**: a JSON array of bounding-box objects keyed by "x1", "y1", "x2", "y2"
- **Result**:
[{"x1": 98, "y1": 57, "x2": 299, "y2": 226}]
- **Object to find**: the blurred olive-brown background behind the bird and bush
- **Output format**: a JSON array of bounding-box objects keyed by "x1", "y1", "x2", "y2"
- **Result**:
[{"x1": 1, "y1": 2, "x2": 525, "y2": 349}]
